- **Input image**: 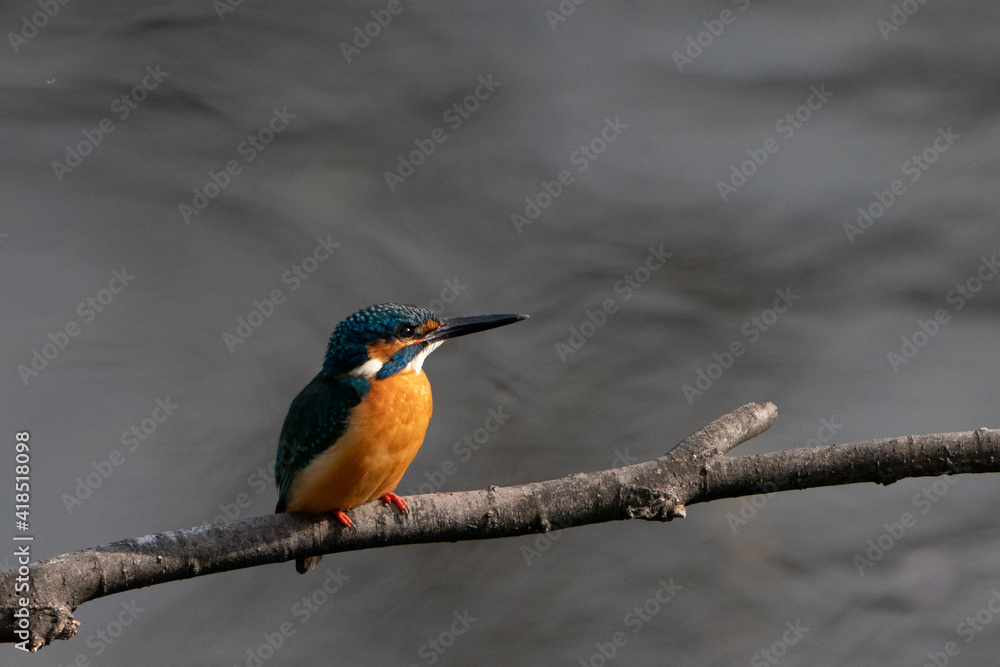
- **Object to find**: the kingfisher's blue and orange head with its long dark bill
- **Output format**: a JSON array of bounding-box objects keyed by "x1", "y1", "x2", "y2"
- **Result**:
[{"x1": 323, "y1": 303, "x2": 527, "y2": 380}]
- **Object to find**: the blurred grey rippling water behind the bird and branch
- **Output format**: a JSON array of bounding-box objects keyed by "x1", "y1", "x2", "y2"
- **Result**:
[{"x1": 0, "y1": 0, "x2": 1000, "y2": 667}]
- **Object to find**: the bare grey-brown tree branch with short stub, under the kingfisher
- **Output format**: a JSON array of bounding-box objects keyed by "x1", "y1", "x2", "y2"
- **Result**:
[{"x1": 0, "y1": 403, "x2": 1000, "y2": 651}]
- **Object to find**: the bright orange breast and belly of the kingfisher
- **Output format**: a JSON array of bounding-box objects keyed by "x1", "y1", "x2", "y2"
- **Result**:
[{"x1": 288, "y1": 371, "x2": 433, "y2": 514}]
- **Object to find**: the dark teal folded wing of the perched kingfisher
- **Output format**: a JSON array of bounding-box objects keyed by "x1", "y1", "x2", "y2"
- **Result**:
[{"x1": 274, "y1": 375, "x2": 368, "y2": 512}]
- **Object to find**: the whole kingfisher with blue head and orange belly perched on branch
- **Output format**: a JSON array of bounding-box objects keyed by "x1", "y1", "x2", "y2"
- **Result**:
[{"x1": 274, "y1": 303, "x2": 527, "y2": 574}]
